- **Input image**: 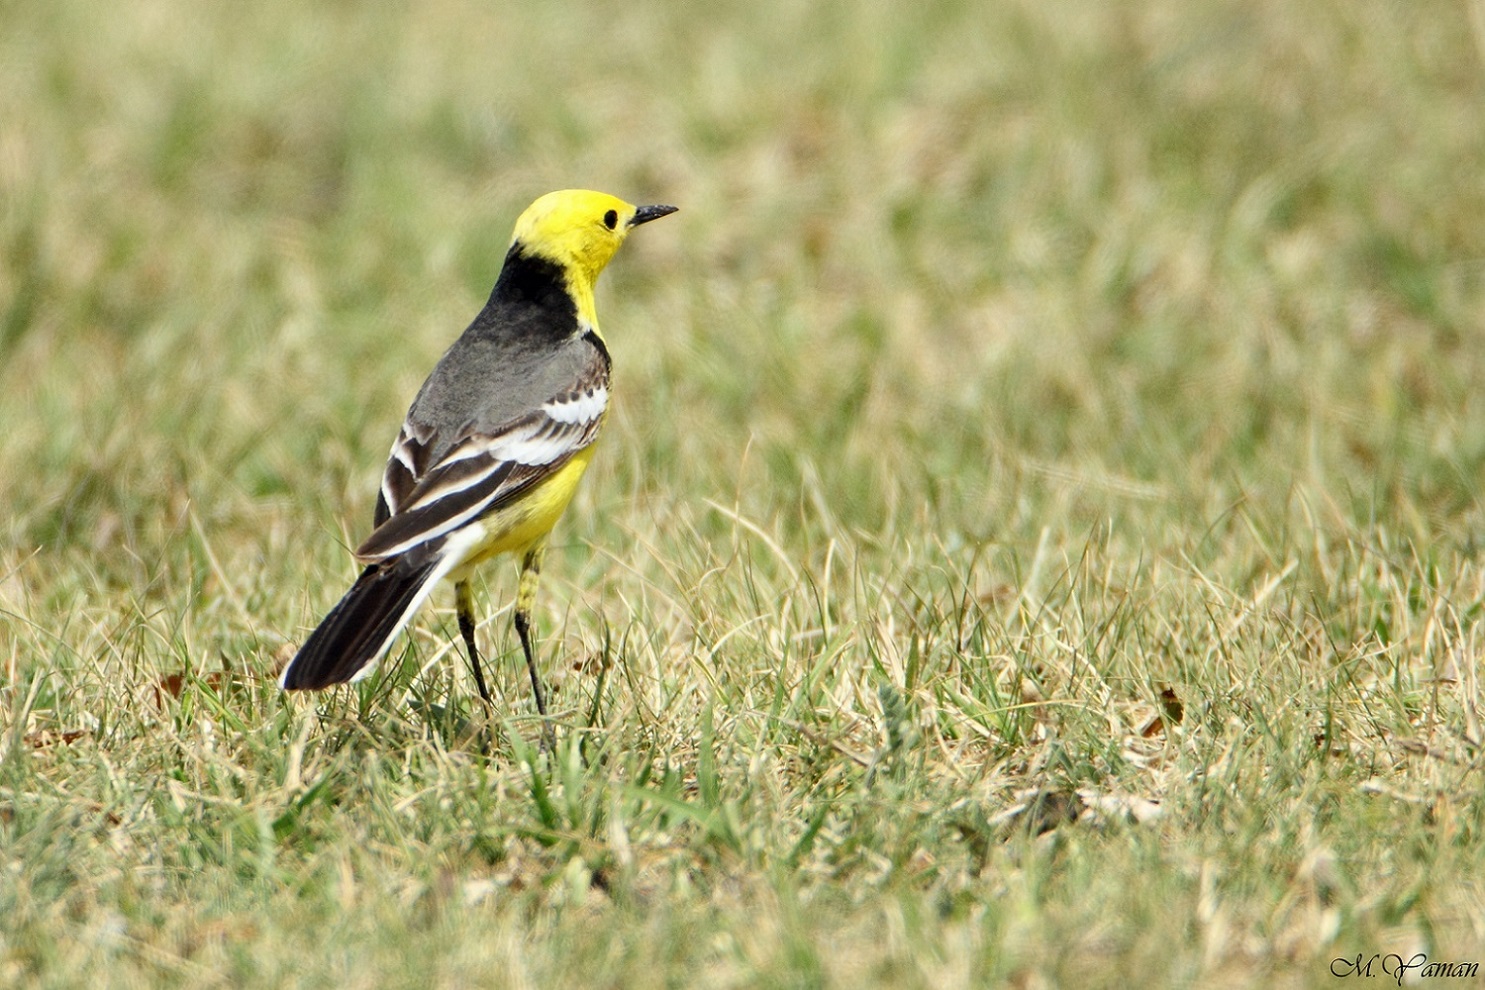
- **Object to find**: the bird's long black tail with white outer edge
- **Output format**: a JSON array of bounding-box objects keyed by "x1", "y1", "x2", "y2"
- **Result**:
[{"x1": 279, "y1": 554, "x2": 438, "y2": 690}]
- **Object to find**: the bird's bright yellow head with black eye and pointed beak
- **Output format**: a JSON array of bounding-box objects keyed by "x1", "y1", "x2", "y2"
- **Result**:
[{"x1": 511, "y1": 189, "x2": 676, "y2": 295}]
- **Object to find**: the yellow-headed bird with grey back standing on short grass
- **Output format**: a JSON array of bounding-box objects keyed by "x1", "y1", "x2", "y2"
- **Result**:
[{"x1": 279, "y1": 189, "x2": 676, "y2": 718}]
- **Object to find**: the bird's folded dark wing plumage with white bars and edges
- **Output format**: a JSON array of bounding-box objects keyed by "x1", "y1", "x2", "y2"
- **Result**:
[{"x1": 356, "y1": 349, "x2": 609, "y2": 563}]
